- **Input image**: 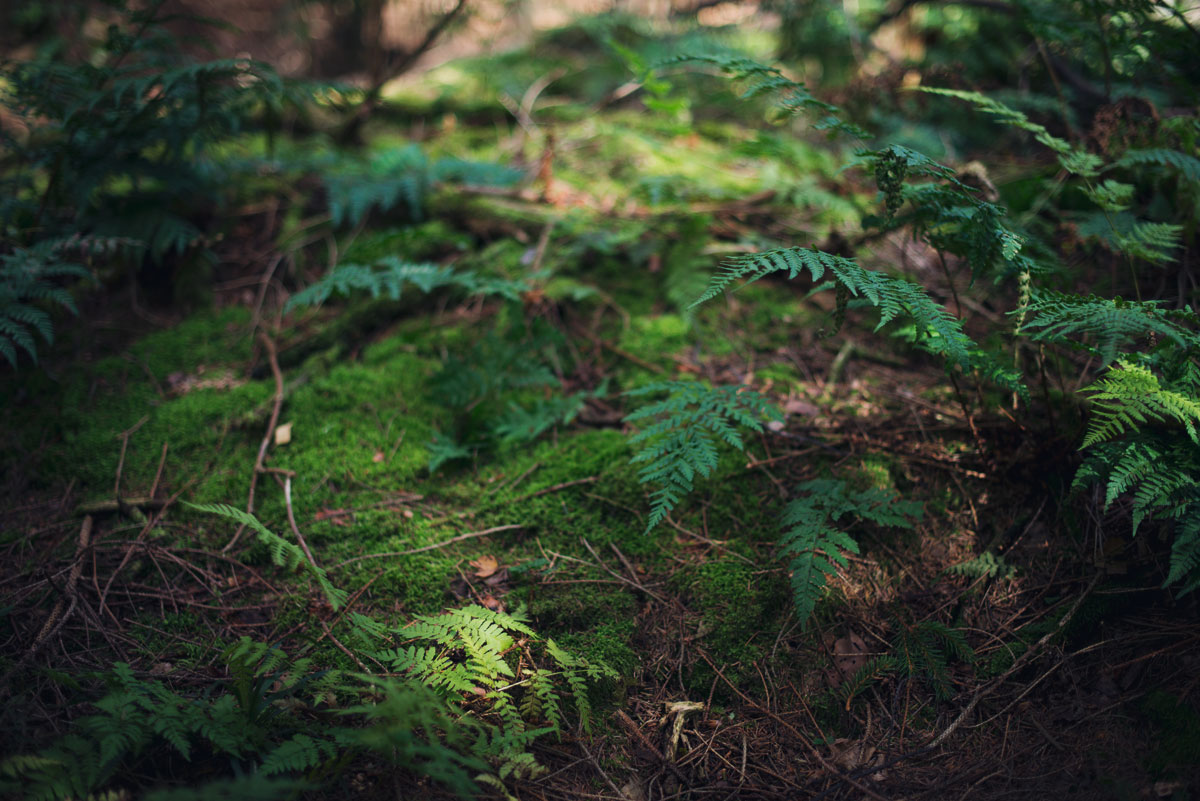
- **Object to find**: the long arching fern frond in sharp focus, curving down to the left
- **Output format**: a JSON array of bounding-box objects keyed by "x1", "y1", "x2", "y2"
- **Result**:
[{"x1": 694, "y1": 247, "x2": 974, "y2": 368}]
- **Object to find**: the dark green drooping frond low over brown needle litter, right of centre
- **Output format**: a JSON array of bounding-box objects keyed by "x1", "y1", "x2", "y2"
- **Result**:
[{"x1": 780, "y1": 478, "x2": 920, "y2": 625}]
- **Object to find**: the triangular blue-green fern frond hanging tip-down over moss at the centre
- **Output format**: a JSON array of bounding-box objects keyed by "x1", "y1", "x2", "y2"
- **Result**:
[{"x1": 625, "y1": 381, "x2": 782, "y2": 531}]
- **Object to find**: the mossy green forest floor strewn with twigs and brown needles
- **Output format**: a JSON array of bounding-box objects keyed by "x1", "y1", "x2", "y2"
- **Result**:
[{"x1": 0, "y1": 20, "x2": 1200, "y2": 801}]
